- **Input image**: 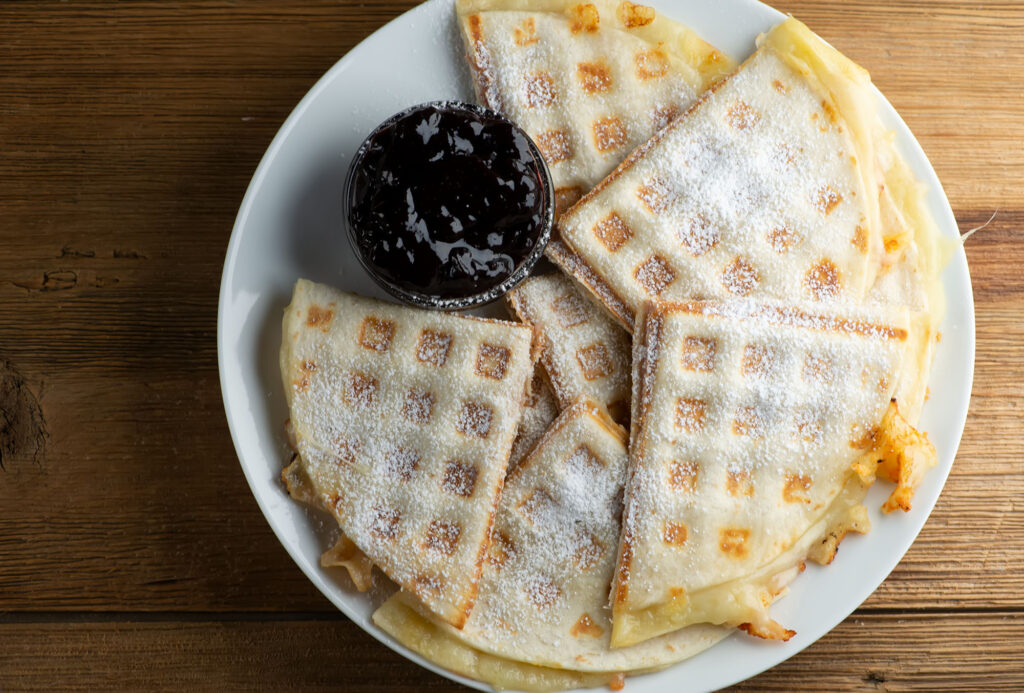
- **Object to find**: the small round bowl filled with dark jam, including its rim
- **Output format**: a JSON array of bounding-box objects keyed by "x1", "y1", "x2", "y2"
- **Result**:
[{"x1": 344, "y1": 100, "x2": 555, "y2": 310}]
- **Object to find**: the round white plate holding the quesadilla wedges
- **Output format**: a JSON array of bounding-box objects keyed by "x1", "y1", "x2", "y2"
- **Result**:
[{"x1": 217, "y1": 0, "x2": 974, "y2": 693}]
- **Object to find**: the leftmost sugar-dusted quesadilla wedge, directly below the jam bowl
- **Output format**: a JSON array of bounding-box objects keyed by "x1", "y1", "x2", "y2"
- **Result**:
[{"x1": 281, "y1": 279, "x2": 535, "y2": 625}]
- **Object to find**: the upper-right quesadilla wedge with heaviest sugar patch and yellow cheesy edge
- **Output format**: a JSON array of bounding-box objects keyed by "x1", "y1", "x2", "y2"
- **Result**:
[{"x1": 558, "y1": 18, "x2": 921, "y2": 329}]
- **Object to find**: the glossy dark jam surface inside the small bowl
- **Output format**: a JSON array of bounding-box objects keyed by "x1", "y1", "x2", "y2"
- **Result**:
[{"x1": 348, "y1": 104, "x2": 547, "y2": 298}]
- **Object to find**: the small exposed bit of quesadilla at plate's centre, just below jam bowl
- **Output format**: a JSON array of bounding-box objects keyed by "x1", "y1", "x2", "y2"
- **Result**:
[{"x1": 505, "y1": 272, "x2": 631, "y2": 423}]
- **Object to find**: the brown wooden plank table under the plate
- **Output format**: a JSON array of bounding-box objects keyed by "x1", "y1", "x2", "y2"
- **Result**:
[{"x1": 0, "y1": 0, "x2": 1024, "y2": 692}]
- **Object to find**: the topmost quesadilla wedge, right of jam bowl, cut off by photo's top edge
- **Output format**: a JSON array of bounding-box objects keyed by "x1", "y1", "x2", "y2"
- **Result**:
[{"x1": 456, "y1": 0, "x2": 734, "y2": 213}]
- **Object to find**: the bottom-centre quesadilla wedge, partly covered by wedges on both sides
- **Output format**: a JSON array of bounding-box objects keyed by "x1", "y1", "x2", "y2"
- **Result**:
[{"x1": 374, "y1": 400, "x2": 728, "y2": 690}]
